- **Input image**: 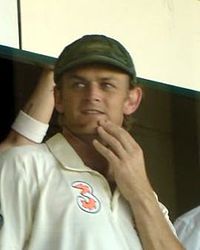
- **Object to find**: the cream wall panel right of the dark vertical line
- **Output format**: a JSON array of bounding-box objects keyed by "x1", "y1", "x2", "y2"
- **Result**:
[{"x1": 21, "y1": 0, "x2": 200, "y2": 90}]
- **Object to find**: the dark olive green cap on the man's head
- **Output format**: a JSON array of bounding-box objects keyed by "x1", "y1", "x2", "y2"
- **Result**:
[{"x1": 54, "y1": 35, "x2": 136, "y2": 83}]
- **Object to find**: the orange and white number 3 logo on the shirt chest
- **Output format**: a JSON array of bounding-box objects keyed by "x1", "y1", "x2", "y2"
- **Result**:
[{"x1": 72, "y1": 181, "x2": 101, "y2": 213}]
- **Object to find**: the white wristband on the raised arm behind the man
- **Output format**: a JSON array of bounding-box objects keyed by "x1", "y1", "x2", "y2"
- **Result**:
[{"x1": 11, "y1": 110, "x2": 49, "y2": 143}]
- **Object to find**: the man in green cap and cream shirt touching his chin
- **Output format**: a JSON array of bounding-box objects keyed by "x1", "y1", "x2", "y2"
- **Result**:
[{"x1": 0, "y1": 35, "x2": 183, "y2": 250}]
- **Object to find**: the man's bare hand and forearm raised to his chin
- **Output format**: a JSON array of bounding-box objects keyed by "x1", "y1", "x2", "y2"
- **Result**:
[{"x1": 94, "y1": 121, "x2": 184, "y2": 250}]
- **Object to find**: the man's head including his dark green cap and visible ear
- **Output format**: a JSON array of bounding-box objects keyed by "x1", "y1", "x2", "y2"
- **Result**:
[{"x1": 54, "y1": 35, "x2": 142, "y2": 135}]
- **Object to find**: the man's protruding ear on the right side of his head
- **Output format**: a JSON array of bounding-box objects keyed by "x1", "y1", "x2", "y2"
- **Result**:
[{"x1": 124, "y1": 87, "x2": 142, "y2": 115}]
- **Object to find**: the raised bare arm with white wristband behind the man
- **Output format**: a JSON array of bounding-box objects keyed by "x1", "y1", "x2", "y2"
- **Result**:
[{"x1": 0, "y1": 68, "x2": 55, "y2": 152}]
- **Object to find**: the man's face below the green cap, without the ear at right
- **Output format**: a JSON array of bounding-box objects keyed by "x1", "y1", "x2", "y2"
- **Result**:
[{"x1": 56, "y1": 65, "x2": 134, "y2": 135}]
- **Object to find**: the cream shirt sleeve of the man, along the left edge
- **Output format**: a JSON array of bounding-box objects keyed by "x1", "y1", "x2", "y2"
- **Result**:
[{"x1": 0, "y1": 150, "x2": 38, "y2": 250}]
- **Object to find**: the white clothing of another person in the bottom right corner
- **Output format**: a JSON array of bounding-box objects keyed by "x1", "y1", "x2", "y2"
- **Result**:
[{"x1": 174, "y1": 206, "x2": 200, "y2": 250}]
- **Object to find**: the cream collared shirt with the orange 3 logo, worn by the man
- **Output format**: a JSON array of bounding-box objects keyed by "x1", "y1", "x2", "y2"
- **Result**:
[{"x1": 0, "y1": 134, "x2": 173, "y2": 250}]
